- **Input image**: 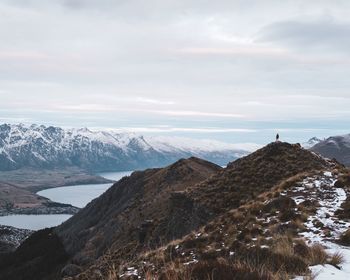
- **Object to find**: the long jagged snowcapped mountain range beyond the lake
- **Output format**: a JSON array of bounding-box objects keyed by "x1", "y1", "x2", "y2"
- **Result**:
[{"x1": 0, "y1": 124, "x2": 253, "y2": 172}]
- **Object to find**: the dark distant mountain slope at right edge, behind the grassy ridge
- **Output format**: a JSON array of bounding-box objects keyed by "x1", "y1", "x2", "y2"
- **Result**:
[{"x1": 310, "y1": 134, "x2": 350, "y2": 166}]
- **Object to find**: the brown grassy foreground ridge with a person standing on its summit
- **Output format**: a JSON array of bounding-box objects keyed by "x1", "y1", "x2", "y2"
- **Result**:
[{"x1": 0, "y1": 142, "x2": 350, "y2": 280}]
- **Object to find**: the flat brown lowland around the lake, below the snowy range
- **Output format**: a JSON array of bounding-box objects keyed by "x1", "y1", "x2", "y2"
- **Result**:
[{"x1": 0, "y1": 169, "x2": 115, "y2": 216}]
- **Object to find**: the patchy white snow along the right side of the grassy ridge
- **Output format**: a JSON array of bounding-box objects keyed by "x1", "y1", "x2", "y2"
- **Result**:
[{"x1": 291, "y1": 171, "x2": 350, "y2": 280}]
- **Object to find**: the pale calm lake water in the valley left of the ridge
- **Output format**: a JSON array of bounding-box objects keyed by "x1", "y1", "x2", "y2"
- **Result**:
[{"x1": 0, "y1": 171, "x2": 132, "y2": 230}]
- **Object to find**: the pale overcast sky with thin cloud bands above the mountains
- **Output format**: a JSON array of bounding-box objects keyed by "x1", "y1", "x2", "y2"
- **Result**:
[{"x1": 0, "y1": 0, "x2": 350, "y2": 143}]
